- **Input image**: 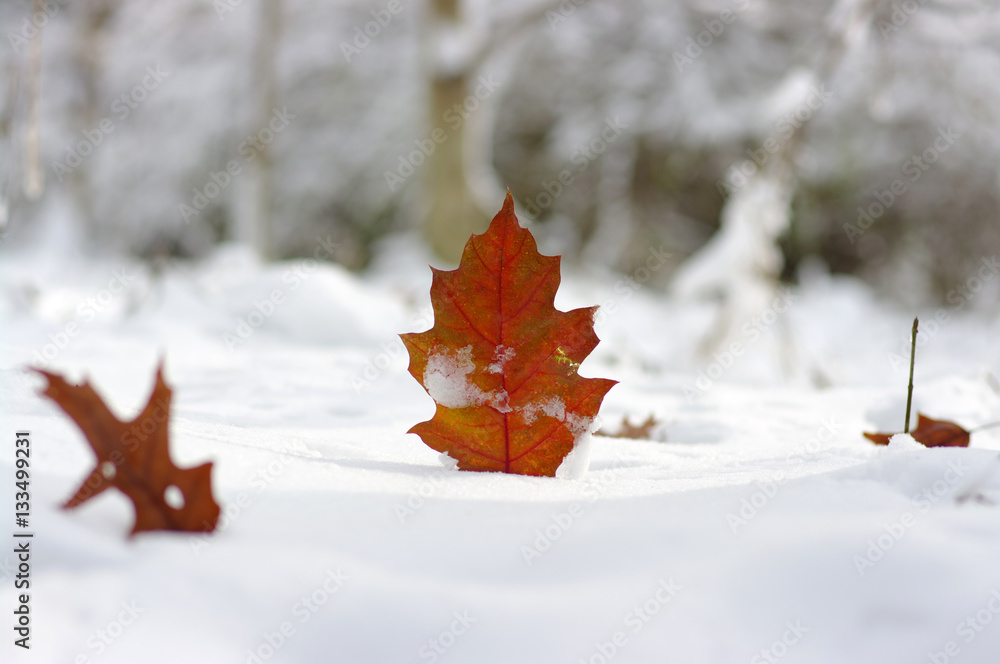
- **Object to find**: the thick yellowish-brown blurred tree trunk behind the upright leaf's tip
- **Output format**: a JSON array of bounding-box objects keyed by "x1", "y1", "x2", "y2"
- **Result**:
[{"x1": 423, "y1": 0, "x2": 489, "y2": 263}]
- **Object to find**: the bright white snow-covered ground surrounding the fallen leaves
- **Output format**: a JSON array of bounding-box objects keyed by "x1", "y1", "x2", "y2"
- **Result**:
[{"x1": 0, "y1": 238, "x2": 1000, "y2": 664}]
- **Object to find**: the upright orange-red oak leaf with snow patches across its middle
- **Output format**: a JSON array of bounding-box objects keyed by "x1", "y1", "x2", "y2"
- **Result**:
[{"x1": 401, "y1": 190, "x2": 615, "y2": 477}]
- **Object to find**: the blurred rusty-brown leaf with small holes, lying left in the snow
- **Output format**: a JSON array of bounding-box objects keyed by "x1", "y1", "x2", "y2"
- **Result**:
[{"x1": 35, "y1": 363, "x2": 219, "y2": 535}]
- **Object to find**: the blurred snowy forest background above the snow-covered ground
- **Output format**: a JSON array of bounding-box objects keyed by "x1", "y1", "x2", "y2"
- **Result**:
[{"x1": 0, "y1": 0, "x2": 1000, "y2": 301}]
